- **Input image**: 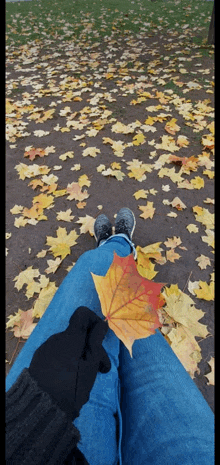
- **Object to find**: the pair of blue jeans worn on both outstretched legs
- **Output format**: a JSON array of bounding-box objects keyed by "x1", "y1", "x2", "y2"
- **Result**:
[{"x1": 6, "y1": 235, "x2": 214, "y2": 465}]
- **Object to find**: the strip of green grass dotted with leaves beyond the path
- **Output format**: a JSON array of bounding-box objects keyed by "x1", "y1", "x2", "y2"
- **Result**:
[{"x1": 6, "y1": 0, "x2": 213, "y2": 46}]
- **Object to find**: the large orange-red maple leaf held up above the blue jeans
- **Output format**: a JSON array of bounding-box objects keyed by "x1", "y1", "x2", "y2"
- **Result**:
[{"x1": 91, "y1": 253, "x2": 163, "y2": 356}]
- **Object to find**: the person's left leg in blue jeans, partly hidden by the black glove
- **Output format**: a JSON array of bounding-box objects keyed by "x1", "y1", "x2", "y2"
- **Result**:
[{"x1": 6, "y1": 236, "x2": 131, "y2": 465}]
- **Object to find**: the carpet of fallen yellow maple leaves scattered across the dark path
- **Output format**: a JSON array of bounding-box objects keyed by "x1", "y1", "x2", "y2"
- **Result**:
[{"x1": 6, "y1": 0, "x2": 214, "y2": 392}]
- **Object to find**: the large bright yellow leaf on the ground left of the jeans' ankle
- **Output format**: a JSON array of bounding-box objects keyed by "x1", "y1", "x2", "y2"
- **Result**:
[{"x1": 46, "y1": 227, "x2": 79, "y2": 260}]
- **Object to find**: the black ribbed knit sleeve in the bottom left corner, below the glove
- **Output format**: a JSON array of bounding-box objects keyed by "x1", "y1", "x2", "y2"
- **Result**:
[{"x1": 6, "y1": 368, "x2": 88, "y2": 465}]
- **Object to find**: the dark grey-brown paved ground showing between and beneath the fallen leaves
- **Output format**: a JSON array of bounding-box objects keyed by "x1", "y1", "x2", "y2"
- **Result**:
[{"x1": 6, "y1": 28, "x2": 214, "y2": 408}]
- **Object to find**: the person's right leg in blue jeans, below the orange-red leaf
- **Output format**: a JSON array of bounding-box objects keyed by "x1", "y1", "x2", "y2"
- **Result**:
[{"x1": 119, "y1": 330, "x2": 214, "y2": 465}]
